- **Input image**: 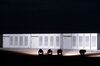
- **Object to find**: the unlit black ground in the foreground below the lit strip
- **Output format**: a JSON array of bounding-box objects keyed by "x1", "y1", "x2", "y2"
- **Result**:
[{"x1": 0, "y1": 49, "x2": 100, "y2": 66}]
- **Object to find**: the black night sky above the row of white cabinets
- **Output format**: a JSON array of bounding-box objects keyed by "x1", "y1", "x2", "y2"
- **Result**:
[{"x1": 0, "y1": 0, "x2": 100, "y2": 33}]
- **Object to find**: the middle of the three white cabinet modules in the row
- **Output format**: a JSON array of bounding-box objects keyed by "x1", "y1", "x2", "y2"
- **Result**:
[{"x1": 31, "y1": 34, "x2": 60, "y2": 49}]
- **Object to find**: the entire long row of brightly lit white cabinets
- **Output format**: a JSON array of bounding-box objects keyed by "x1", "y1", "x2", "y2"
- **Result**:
[{"x1": 3, "y1": 33, "x2": 97, "y2": 50}]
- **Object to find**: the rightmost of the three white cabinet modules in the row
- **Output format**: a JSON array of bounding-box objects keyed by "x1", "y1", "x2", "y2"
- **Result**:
[{"x1": 63, "y1": 33, "x2": 97, "y2": 50}]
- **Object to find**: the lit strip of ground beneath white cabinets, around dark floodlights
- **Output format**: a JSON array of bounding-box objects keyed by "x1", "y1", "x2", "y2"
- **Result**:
[{"x1": 0, "y1": 48, "x2": 100, "y2": 57}]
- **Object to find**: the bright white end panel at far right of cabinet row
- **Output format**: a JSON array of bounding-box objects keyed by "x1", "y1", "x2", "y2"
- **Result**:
[{"x1": 91, "y1": 33, "x2": 97, "y2": 50}]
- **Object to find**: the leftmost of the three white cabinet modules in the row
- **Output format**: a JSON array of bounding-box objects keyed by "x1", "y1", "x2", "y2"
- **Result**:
[{"x1": 3, "y1": 34, "x2": 30, "y2": 48}]
